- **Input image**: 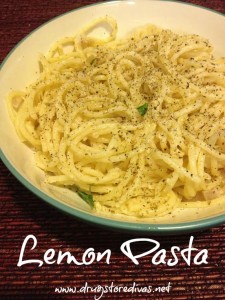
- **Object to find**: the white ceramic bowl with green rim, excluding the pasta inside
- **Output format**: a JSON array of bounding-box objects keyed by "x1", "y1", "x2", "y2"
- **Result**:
[{"x1": 0, "y1": 0, "x2": 225, "y2": 234}]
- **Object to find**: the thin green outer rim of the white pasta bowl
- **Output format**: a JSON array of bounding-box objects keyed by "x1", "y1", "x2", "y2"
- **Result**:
[{"x1": 0, "y1": 0, "x2": 225, "y2": 235}]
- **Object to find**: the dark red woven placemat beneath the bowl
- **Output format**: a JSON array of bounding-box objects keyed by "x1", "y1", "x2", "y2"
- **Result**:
[{"x1": 0, "y1": 0, "x2": 225, "y2": 300}]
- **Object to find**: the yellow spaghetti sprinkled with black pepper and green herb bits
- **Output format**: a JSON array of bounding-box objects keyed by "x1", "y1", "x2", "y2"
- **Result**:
[{"x1": 8, "y1": 16, "x2": 225, "y2": 217}]
